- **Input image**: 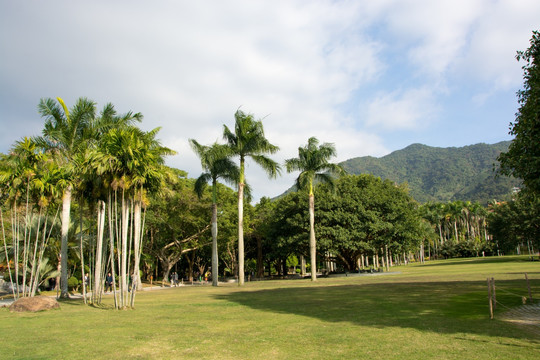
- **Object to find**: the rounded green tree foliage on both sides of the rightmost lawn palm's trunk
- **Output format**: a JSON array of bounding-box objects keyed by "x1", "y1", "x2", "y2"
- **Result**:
[{"x1": 265, "y1": 175, "x2": 425, "y2": 270}]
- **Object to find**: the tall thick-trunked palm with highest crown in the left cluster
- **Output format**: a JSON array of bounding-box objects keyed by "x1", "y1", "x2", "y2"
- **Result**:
[{"x1": 35, "y1": 97, "x2": 96, "y2": 298}]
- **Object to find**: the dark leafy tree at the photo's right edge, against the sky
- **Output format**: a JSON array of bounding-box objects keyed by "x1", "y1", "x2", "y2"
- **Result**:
[{"x1": 499, "y1": 31, "x2": 540, "y2": 195}]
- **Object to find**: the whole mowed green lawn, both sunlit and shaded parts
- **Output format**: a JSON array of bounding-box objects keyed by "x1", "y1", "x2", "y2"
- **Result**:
[{"x1": 0, "y1": 257, "x2": 540, "y2": 359}]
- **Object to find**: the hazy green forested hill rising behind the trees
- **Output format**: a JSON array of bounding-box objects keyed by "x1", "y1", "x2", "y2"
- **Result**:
[{"x1": 341, "y1": 141, "x2": 521, "y2": 204}]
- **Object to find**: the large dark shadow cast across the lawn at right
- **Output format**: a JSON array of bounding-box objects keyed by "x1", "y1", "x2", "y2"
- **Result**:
[{"x1": 217, "y1": 280, "x2": 540, "y2": 342}]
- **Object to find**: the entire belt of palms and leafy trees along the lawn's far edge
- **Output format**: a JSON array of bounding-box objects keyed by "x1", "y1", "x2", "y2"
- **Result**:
[{"x1": 0, "y1": 87, "x2": 540, "y2": 309}]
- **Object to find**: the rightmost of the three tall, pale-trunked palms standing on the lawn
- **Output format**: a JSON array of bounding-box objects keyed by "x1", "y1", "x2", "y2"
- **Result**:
[{"x1": 285, "y1": 137, "x2": 344, "y2": 281}]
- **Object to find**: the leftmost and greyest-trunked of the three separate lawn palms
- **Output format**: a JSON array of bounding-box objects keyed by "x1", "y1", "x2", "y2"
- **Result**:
[{"x1": 189, "y1": 139, "x2": 240, "y2": 286}]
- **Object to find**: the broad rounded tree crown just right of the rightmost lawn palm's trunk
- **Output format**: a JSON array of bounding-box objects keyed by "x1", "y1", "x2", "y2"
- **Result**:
[{"x1": 316, "y1": 175, "x2": 422, "y2": 270}]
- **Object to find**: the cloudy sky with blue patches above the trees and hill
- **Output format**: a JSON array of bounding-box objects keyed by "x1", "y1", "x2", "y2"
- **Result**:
[{"x1": 0, "y1": 0, "x2": 540, "y2": 201}]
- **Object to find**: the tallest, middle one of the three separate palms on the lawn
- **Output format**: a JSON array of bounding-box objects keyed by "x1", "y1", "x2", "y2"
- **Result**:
[{"x1": 223, "y1": 109, "x2": 281, "y2": 285}]
